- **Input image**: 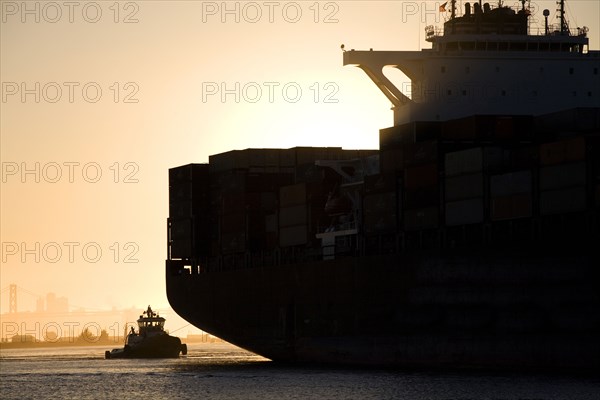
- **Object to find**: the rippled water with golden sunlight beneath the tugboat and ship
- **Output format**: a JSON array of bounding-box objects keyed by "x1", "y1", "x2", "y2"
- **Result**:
[{"x1": 0, "y1": 344, "x2": 600, "y2": 400}]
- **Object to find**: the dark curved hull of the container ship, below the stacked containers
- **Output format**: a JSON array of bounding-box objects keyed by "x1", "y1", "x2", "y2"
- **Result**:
[{"x1": 167, "y1": 245, "x2": 600, "y2": 371}]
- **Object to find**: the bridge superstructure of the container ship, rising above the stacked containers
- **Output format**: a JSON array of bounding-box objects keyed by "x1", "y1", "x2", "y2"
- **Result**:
[{"x1": 343, "y1": 0, "x2": 600, "y2": 125}]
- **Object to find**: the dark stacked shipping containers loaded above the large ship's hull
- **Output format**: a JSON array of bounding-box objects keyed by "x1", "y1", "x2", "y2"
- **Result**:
[{"x1": 169, "y1": 110, "x2": 600, "y2": 272}]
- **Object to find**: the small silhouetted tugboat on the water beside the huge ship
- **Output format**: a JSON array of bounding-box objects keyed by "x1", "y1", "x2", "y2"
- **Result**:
[{"x1": 104, "y1": 306, "x2": 187, "y2": 359}]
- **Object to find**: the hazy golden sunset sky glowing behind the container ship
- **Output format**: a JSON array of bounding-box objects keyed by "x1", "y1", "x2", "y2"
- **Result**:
[{"x1": 0, "y1": 0, "x2": 600, "y2": 312}]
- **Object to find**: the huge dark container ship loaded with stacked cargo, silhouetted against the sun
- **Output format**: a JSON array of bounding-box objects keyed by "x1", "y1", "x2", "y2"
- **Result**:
[{"x1": 166, "y1": 0, "x2": 600, "y2": 371}]
